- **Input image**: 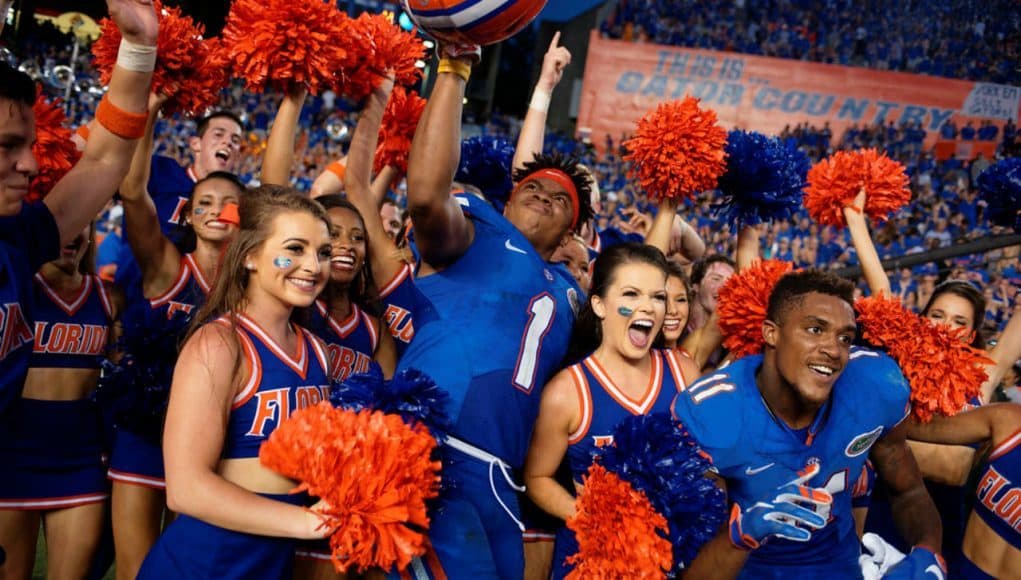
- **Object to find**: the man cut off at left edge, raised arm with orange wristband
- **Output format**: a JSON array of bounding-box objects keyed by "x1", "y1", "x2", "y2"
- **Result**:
[{"x1": 0, "y1": 0, "x2": 158, "y2": 415}]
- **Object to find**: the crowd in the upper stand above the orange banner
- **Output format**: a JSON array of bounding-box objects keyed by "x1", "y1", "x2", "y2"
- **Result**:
[{"x1": 599, "y1": 0, "x2": 1021, "y2": 85}]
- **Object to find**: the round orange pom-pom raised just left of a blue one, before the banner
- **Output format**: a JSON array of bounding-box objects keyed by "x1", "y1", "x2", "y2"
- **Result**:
[{"x1": 624, "y1": 97, "x2": 727, "y2": 199}]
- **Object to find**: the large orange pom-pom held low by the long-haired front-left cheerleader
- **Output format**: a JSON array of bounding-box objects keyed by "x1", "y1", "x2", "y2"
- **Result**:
[{"x1": 259, "y1": 402, "x2": 440, "y2": 572}]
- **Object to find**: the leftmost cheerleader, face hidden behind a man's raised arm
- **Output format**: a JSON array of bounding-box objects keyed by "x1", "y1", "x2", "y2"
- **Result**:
[{"x1": 0, "y1": 226, "x2": 121, "y2": 578}]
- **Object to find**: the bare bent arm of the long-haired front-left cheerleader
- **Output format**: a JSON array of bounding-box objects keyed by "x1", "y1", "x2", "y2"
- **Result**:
[{"x1": 163, "y1": 324, "x2": 327, "y2": 538}]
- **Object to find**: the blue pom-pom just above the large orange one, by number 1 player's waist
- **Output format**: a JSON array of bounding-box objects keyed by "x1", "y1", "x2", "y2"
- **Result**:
[{"x1": 330, "y1": 363, "x2": 451, "y2": 442}]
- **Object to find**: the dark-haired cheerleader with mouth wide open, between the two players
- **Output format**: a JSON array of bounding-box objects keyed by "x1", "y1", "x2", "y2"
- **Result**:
[{"x1": 525, "y1": 243, "x2": 698, "y2": 578}]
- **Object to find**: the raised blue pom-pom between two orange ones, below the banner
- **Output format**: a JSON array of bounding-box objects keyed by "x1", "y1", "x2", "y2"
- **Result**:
[{"x1": 713, "y1": 130, "x2": 812, "y2": 226}]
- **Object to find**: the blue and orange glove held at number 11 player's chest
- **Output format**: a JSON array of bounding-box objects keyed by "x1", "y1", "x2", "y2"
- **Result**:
[{"x1": 730, "y1": 465, "x2": 833, "y2": 549}]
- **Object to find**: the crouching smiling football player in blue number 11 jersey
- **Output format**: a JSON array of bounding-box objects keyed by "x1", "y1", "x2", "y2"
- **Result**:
[{"x1": 674, "y1": 270, "x2": 945, "y2": 578}]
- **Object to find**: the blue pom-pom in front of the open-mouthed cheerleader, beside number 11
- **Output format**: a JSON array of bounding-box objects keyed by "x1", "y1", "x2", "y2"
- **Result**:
[{"x1": 596, "y1": 413, "x2": 727, "y2": 576}]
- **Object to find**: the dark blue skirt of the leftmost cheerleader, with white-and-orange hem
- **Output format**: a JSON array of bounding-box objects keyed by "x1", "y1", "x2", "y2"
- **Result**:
[{"x1": 0, "y1": 398, "x2": 109, "y2": 511}]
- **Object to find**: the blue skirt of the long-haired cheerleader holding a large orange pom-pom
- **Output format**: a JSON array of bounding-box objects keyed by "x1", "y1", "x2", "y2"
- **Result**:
[{"x1": 138, "y1": 493, "x2": 307, "y2": 580}]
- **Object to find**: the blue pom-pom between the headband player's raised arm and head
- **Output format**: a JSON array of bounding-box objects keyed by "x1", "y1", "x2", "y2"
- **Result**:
[{"x1": 454, "y1": 135, "x2": 515, "y2": 211}]
